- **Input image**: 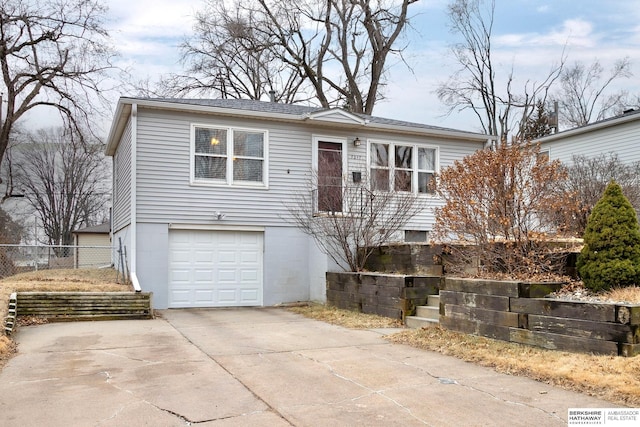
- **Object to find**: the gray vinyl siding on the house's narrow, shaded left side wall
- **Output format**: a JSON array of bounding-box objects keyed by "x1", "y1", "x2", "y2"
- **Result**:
[{"x1": 112, "y1": 120, "x2": 131, "y2": 231}]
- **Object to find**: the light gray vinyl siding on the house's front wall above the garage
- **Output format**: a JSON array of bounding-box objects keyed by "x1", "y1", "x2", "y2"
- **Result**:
[{"x1": 137, "y1": 108, "x2": 482, "y2": 230}]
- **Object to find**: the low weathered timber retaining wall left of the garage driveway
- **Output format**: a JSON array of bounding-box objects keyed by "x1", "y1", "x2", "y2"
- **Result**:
[{"x1": 16, "y1": 292, "x2": 153, "y2": 322}]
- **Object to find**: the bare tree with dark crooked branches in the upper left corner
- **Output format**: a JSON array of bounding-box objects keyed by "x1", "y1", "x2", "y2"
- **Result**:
[{"x1": 0, "y1": 0, "x2": 112, "y2": 176}]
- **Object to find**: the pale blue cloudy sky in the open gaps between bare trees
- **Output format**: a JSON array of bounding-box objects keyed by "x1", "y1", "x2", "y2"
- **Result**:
[{"x1": 96, "y1": 0, "x2": 640, "y2": 131}]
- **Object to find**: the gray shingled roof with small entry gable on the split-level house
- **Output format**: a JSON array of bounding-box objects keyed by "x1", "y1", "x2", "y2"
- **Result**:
[{"x1": 107, "y1": 97, "x2": 491, "y2": 155}]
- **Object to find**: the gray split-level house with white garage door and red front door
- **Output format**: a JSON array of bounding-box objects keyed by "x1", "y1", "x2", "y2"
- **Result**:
[{"x1": 106, "y1": 98, "x2": 487, "y2": 308}]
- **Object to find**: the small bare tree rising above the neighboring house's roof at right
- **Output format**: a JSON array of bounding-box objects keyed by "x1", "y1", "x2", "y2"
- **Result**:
[{"x1": 557, "y1": 57, "x2": 632, "y2": 127}]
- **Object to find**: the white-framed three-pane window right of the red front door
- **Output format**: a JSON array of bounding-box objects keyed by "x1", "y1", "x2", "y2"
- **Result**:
[{"x1": 369, "y1": 143, "x2": 437, "y2": 194}]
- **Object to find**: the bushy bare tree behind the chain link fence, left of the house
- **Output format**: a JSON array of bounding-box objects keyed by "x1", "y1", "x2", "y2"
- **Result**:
[{"x1": 11, "y1": 128, "x2": 108, "y2": 245}]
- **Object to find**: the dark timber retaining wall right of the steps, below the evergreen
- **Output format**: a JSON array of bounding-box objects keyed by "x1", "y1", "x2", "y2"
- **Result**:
[{"x1": 440, "y1": 277, "x2": 640, "y2": 357}]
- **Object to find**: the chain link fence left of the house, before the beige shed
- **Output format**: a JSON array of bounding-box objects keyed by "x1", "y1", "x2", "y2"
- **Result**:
[{"x1": 0, "y1": 245, "x2": 122, "y2": 278}]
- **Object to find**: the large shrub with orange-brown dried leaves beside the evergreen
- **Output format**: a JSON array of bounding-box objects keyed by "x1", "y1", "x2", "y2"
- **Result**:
[{"x1": 434, "y1": 144, "x2": 573, "y2": 277}]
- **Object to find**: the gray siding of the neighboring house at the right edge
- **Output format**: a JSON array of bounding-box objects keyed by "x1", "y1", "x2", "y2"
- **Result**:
[{"x1": 541, "y1": 120, "x2": 640, "y2": 168}]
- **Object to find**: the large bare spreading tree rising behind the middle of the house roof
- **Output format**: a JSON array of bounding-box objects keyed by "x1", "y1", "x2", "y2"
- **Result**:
[{"x1": 165, "y1": 0, "x2": 417, "y2": 114}]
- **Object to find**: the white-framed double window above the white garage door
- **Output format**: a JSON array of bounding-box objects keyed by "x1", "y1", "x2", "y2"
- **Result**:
[{"x1": 192, "y1": 126, "x2": 267, "y2": 185}]
